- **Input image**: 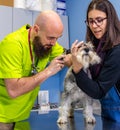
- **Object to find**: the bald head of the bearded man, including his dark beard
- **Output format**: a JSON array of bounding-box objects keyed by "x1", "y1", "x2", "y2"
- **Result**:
[{"x1": 31, "y1": 10, "x2": 63, "y2": 57}]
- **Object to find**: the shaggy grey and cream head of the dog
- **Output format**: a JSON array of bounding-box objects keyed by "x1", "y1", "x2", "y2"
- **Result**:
[{"x1": 77, "y1": 42, "x2": 101, "y2": 69}]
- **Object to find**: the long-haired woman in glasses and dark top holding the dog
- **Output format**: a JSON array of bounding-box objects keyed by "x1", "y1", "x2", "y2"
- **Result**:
[{"x1": 71, "y1": 0, "x2": 120, "y2": 122}]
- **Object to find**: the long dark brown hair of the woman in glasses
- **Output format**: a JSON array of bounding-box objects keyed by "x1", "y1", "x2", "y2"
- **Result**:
[{"x1": 86, "y1": 0, "x2": 120, "y2": 50}]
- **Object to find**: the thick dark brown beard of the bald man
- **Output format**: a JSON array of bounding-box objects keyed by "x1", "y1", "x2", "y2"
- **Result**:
[{"x1": 33, "y1": 36, "x2": 52, "y2": 59}]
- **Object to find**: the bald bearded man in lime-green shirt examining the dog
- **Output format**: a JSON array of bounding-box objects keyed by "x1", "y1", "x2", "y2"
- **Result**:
[{"x1": 0, "y1": 11, "x2": 69, "y2": 126}]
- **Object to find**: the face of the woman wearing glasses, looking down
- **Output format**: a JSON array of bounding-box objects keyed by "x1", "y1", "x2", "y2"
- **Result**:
[{"x1": 87, "y1": 9, "x2": 107, "y2": 39}]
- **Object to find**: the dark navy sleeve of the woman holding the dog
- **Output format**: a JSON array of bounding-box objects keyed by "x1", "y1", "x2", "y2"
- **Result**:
[{"x1": 73, "y1": 45, "x2": 120, "y2": 99}]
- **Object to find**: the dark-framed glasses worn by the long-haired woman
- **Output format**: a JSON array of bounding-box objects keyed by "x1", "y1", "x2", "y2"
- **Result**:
[{"x1": 85, "y1": 17, "x2": 107, "y2": 26}]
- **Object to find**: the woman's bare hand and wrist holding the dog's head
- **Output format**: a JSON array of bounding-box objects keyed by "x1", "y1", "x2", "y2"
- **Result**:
[{"x1": 71, "y1": 40, "x2": 83, "y2": 73}]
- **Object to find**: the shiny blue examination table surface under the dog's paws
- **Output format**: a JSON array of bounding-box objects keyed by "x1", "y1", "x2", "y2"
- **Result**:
[{"x1": 15, "y1": 110, "x2": 120, "y2": 130}]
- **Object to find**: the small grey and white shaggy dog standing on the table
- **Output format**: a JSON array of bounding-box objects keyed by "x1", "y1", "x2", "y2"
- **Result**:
[{"x1": 57, "y1": 42, "x2": 101, "y2": 124}]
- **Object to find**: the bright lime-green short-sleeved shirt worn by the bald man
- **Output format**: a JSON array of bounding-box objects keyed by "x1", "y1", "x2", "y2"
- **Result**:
[{"x1": 0, "y1": 25, "x2": 63, "y2": 122}]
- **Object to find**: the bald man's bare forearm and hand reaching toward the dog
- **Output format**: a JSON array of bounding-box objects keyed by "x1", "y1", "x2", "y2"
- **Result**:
[{"x1": 4, "y1": 57, "x2": 64, "y2": 98}]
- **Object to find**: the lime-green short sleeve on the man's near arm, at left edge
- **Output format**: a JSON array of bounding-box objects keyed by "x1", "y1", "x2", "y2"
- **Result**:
[{"x1": 0, "y1": 38, "x2": 22, "y2": 78}]
